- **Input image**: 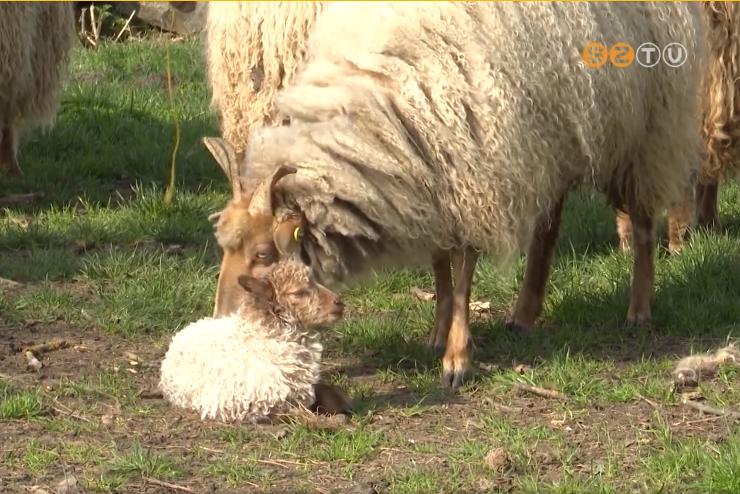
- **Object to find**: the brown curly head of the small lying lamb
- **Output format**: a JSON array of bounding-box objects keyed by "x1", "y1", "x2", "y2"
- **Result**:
[{"x1": 238, "y1": 260, "x2": 344, "y2": 328}]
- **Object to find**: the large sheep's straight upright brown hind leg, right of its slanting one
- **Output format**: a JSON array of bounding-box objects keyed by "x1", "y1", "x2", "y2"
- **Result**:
[{"x1": 627, "y1": 212, "x2": 655, "y2": 325}]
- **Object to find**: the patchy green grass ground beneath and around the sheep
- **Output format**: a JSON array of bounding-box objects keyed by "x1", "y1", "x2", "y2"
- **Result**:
[{"x1": 0, "y1": 36, "x2": 740, "y2": 494}]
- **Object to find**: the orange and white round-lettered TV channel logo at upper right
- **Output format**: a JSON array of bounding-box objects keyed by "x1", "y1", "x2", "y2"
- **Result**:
[{"x1": 581, "y1": 41, "x2": 689, "y2": 69}]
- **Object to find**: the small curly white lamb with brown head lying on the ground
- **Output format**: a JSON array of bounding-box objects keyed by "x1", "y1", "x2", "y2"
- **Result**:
[{"x1": 160, "y1": 260, "x2": 348, "y2": 422}]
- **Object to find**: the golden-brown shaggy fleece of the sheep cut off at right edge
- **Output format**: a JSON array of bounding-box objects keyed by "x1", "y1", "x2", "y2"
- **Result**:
[{"x1": 702, "y1": 2, "x2": 740, "y2": 181}]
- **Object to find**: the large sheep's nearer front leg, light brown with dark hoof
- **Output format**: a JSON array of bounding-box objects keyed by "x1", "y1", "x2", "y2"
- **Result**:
[{"x1": 442, "y1": 247, "x2": 478, "y2": 390}]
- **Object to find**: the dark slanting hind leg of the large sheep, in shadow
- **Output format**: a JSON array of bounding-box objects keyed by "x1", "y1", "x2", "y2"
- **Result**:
[{"x1": 506, "y1": 195, "x2": 565, "y2": 331}]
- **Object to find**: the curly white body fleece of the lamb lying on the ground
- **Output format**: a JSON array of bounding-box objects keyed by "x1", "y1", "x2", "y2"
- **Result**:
[{"x1": 159, "y1": 315, "x2": 322, "y2": 422}]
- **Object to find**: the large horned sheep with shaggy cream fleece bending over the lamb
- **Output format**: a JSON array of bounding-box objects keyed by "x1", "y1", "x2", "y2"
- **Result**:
[{"x1": 202, "y1": 2, "x2": 704, "y2": 388}]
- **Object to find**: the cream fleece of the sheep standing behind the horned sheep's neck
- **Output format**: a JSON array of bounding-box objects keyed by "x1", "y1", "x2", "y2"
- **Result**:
[{"x1": 206, "y1": 2, "x2": 322, "y2": 153}]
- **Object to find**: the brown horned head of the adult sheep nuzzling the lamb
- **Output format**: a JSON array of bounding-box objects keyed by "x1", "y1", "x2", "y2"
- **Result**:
[{"x1": 203, "y1": 137, "x2": 303, "y2": 317}]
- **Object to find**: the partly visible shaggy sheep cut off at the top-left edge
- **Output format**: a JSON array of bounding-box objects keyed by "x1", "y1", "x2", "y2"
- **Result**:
[{"x1": 0, "y1": 2, "x2": 75, "y2": 176}]
